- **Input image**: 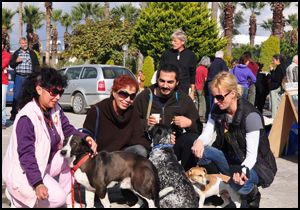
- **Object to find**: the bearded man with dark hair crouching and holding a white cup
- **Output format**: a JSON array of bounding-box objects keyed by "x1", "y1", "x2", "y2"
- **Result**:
[{"x1": 133, "y1": 64, "x2": 203, "y2": 170}]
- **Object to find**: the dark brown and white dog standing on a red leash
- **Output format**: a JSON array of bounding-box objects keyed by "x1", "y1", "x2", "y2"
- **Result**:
[{"x1": 61, "y1": 135, "x2": 159, "y2": 208}]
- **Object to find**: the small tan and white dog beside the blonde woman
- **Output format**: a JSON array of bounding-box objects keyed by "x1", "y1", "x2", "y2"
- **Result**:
[{"x1": 186, "y1": 166, "x2": 241, "y2": 208}]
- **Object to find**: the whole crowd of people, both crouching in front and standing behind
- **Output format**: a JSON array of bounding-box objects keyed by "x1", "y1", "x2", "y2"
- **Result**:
[{"x1": 2, "y1": 29, "x2": 298, "y2": 208}]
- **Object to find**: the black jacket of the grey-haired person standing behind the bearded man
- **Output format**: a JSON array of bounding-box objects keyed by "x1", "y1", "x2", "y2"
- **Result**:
[{"x1": 159, "y1": 49, "x2": 197, "y2": 92}]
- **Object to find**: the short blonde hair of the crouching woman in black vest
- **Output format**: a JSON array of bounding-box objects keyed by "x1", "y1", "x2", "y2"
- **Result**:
[{"x1": 209, "y1": 71, "x2": 243, "y2": 98}]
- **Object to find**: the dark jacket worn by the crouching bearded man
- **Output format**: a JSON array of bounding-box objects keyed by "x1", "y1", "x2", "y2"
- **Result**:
[{"x1": 133, "y1": 85, "x2": 203, "y2": 134}]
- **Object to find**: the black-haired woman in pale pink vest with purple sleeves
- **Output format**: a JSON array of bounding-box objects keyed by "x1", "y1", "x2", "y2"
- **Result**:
[{"x1": 2, "y1": 67, "x2": 97, "y2": 208}]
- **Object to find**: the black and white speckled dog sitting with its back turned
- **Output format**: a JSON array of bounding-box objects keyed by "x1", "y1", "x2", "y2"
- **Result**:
[{"x1": 148, "y1": 124, "x2": 198, "y2": 208}]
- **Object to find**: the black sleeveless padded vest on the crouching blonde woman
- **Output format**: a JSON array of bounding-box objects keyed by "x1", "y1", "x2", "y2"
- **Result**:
[{"x1": 211, "y1": 98, "x2": 277, "y2": 187}]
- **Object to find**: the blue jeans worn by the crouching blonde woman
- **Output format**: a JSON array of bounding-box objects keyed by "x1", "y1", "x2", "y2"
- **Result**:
[{"x1": 198, "y1": 146, "x2": 259, "y2": 195}]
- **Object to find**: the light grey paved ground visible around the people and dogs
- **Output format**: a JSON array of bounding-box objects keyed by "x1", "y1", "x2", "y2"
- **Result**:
[{"x1": 2, "y1": 107, "x2": 298, "y2": 208}]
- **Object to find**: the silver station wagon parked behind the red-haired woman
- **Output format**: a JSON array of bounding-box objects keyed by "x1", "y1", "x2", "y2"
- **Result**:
[{"x1": 58, "y1": 64, "x2": 136, "y2": 114}]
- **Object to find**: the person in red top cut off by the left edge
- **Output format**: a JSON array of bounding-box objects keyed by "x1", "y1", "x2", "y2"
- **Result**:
[{"x1": 2, "y1": 38, "x2": 11, "y2": 129}]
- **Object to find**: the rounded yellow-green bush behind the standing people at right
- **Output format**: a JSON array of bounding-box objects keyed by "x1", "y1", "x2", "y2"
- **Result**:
[{"x1": 259, "y1": 36, "x2": 280, "y2": 72}]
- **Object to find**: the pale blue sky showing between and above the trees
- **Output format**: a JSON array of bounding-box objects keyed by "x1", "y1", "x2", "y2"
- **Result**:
[{"x1": 2, "y1": 2, "x2": 298, "y2": 50}]
